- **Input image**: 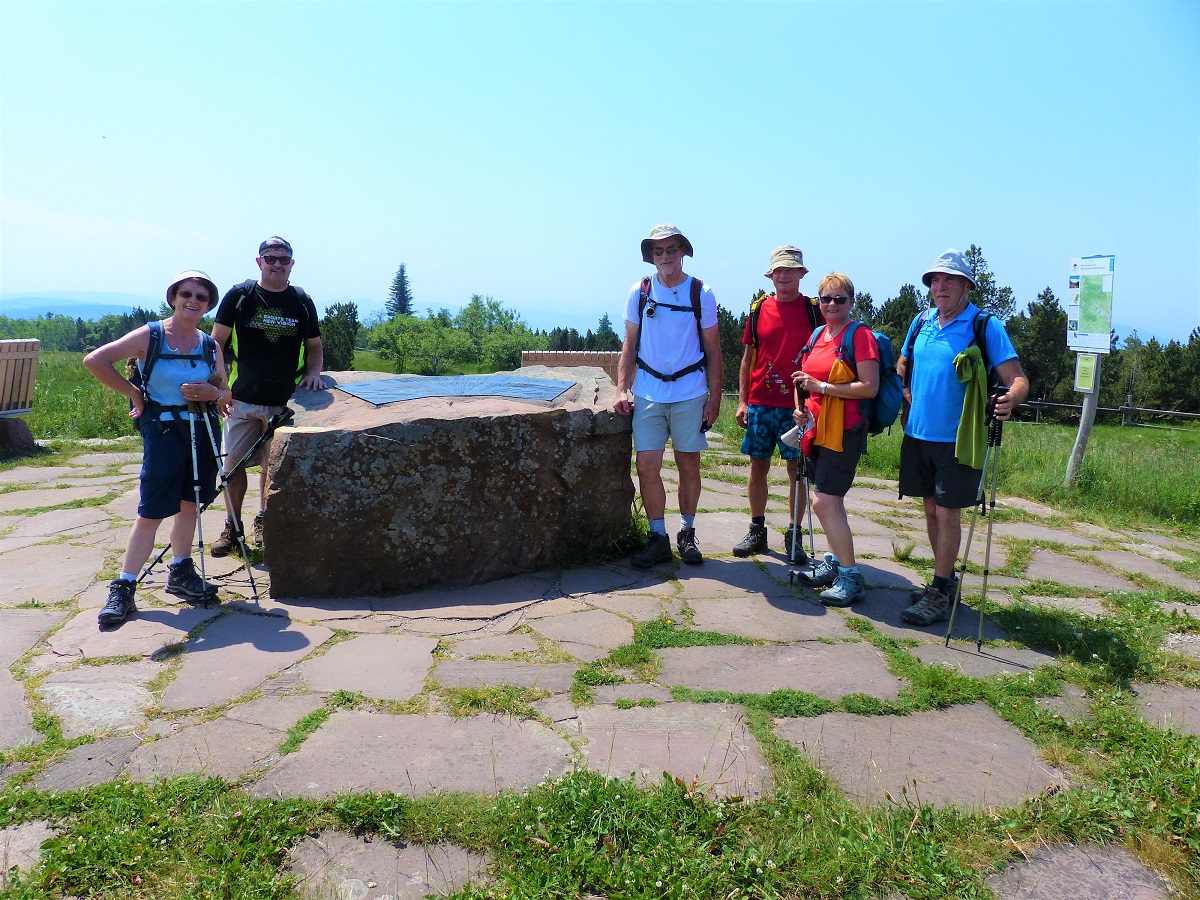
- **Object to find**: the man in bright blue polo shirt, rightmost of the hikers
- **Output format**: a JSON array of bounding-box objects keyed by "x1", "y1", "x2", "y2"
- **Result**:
[{"x1": 896, "y1": 250, "x2": 1030, "y2": 625}]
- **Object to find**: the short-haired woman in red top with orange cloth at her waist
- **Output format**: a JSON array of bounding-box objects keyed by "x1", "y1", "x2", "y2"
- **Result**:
[{"x1": 792, "y1": 272, "x2": 880, "y2": 606}]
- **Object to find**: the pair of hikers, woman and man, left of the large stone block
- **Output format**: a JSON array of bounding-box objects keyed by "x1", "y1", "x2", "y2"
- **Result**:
[{"x1": 84, "y1": 236, "x2": 324, "y2": 628}]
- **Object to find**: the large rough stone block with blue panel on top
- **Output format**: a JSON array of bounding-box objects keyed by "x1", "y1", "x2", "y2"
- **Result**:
[{"x1": 264, "y1": 366, "x2": 634, "y2": 596}]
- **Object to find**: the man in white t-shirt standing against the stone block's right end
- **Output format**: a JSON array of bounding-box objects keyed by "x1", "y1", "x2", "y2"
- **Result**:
[{"x1": 613, "y1": 224, "x2": 722, "y2": 569}]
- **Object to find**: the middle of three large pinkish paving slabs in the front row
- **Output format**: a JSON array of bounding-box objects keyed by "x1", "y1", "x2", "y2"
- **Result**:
[{"x1": 576, "y1": 703, "x2": 772, "y2": 799}]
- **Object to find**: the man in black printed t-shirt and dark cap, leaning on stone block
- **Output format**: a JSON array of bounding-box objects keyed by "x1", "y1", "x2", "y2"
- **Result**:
[{"x1": 210, "y1": 236, "x2": 325, "y2": 557}]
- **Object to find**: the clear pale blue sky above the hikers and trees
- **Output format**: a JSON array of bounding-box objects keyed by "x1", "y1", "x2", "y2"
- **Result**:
[{"x1": 0, "y1": 0, "x2": 1200, "y2": 340}]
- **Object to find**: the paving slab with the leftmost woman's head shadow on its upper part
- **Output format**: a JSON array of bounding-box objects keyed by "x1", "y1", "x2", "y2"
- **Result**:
[{"x1": 162, "y1": 613, "x2": 334, "y2": 709}]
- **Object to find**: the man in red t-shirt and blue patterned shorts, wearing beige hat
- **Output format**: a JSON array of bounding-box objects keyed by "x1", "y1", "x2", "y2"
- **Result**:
[{"x1": 733, "y1": 245, "x2": 823, "y2": 565}]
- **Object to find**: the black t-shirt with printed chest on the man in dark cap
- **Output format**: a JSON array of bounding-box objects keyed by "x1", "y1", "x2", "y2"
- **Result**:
[{"x1": 216, "y1": 281, "x2": 320, "y2": 407}]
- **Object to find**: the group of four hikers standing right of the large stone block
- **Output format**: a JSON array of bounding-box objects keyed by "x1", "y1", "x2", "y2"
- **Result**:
[{"x1": 613, "y1": 224, "x2": 1028, "y2": 625}]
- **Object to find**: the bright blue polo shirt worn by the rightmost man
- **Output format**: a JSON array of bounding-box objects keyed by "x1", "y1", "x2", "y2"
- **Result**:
[{"x1": 904, "y1": 304, "x2": 1016, "y2": 443}]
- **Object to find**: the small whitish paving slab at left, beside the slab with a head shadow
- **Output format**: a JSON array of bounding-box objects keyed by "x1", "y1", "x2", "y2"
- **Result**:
[{"x1": 37, "y1": 662, "x2": 163, "y2": 740}]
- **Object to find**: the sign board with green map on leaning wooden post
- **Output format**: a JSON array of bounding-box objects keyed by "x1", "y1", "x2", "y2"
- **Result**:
[{"x1": 1066, "y1": 256, "x2": 1117, "y2": 487}]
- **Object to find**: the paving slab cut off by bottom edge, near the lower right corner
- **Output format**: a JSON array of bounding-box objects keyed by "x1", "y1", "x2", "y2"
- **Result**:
[{"x1": 984, "y1": 845, "x2": 1172, "y2": 900}]
